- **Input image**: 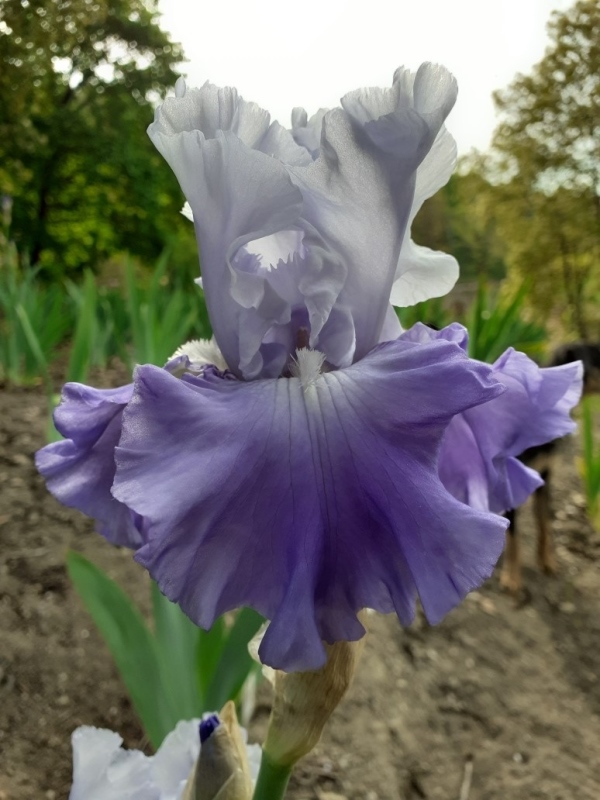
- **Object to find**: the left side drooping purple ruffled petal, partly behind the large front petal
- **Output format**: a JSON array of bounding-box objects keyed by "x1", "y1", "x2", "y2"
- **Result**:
[{"x1": 35, "y1": 383, "x2": 142, "y2": 548}]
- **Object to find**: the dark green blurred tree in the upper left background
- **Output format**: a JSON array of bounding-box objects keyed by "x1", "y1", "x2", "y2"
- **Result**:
[{"x1": 0, "y1": 0, "x2": 191, "y2": 274}]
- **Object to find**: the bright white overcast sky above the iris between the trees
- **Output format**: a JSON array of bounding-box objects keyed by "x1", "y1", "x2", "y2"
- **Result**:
[{"x1": 160, "y1": 0, "x2": 574, "y2": 153}]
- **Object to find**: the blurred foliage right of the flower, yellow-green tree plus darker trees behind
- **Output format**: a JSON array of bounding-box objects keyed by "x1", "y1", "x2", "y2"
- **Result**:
[{"x1": 415, "y1": 0, "x2": 600, "y2": 339}]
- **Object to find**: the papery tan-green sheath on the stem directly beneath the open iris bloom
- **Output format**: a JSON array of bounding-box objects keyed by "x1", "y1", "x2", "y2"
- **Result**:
[{"x1": 263, "y1": 637, "x2": 365, "y2": 766}]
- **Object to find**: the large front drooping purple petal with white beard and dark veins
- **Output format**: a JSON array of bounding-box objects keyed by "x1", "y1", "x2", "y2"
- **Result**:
[{"x1": 113, "y1": 340, "x2": 505, "y2": 671}]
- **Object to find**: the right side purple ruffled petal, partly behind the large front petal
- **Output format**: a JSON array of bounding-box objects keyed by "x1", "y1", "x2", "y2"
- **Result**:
[{"x1": 440, "y1": 349, "x2": 583, "y2": 513}]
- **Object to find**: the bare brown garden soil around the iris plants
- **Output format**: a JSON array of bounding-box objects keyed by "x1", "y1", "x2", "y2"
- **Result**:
[{"x1": 0, "y1": 384, "x2": 600, "y2": 800}]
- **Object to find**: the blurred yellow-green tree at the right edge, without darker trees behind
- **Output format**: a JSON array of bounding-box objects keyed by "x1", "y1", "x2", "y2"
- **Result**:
[{"x1": 488, "y1": 0, "x2": 600, "y2": 338}]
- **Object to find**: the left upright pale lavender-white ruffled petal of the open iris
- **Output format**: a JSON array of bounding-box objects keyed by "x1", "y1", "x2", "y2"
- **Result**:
[{"x1": 148, "y1": 83, "x2": 311, "y2": 378}]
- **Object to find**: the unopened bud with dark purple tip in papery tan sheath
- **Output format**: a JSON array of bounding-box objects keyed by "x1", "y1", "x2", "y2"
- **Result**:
[{"x1": 182, "y1": 701, "x2": 252, "y2": 800}]
